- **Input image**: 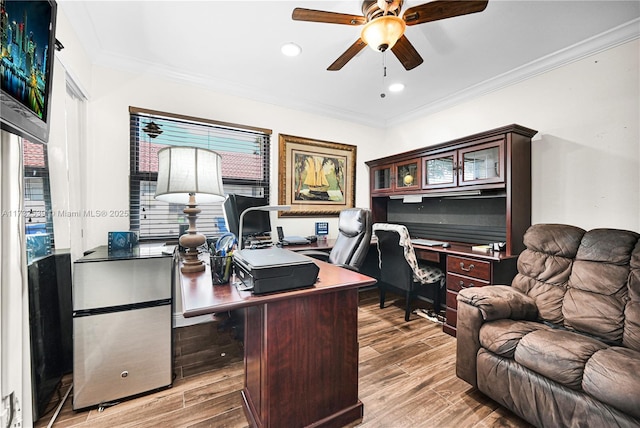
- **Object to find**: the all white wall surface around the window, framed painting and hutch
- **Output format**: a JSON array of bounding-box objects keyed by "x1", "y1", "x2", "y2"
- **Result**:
[{"x1": 54, "y1": 13, "x2": 640, "y2": 250}]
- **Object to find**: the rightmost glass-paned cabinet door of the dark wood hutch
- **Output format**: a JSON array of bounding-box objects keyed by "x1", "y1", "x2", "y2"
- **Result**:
[{"x1": 458, "y1": 139, "x2": 505, "y2": 186}]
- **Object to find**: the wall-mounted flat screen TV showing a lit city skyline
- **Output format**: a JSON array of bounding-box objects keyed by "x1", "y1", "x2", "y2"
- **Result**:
[{"x1": 0, "y1": 0, "x2": 57, "y2": 143}]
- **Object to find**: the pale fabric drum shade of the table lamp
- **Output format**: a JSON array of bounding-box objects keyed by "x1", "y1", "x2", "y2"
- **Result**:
[{"x1": 155, "y1": 147, "x2": 224, "y2": 204}]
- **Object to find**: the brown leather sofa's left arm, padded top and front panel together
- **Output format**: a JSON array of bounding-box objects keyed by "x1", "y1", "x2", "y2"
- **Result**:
[{"x1": 456, "y1": 285, "x2": 538, "y2": 387}]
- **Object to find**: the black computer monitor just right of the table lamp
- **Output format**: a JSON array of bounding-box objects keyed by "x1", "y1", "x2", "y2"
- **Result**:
[{"x1": 222, "y1": 193, "x2": 271, "y2": 238}]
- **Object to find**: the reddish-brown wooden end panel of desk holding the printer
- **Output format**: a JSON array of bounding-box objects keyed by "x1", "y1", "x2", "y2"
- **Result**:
[{"x1": 244, "y1": 289, "x2": 362, "y2": 427}]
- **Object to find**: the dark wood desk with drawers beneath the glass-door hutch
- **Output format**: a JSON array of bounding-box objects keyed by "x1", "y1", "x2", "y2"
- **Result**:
[{"x1": 413, "y1": 242, "x2": 518, "y2": 336}]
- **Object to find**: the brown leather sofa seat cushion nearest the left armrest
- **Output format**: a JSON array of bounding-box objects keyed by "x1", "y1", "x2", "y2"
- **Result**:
[{"x1": 479, "y1": 319, "x2": 550, "y2": 359}]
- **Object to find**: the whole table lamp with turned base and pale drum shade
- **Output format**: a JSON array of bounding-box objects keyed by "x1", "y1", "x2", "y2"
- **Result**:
[{"x1": 155, "y1": 147, "x2": 224, "y2": 273}]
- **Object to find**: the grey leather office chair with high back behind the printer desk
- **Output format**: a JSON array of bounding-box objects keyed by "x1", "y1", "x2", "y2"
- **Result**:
[{"x1": 300, "y1": 208, "x2": 372, "y2": 270}]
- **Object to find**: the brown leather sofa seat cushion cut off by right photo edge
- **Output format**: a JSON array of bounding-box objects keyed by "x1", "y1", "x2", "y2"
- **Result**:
[{"x1": 582, "y1": 346, "x2": 640, "y2": 418}]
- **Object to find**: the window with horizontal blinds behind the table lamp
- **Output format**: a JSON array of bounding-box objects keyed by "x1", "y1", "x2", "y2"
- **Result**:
[{"x1": 129, "y1": 107, "x2": 271, "y2": 239}]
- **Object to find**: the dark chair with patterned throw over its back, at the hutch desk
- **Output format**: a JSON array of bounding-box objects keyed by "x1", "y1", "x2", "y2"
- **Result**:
[{"x1": 373, "y1": 223, "x2": 445, "y2": 321}]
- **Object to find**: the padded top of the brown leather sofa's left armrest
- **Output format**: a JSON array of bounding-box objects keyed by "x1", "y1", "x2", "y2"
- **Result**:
[{"x1": 458, "y1": 285, "x2": 538, "y2": 321}]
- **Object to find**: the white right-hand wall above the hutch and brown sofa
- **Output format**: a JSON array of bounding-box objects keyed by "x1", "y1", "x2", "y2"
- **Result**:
[{"x1": 382, "y1": 40, "x2": 640, "y2": 232}]
